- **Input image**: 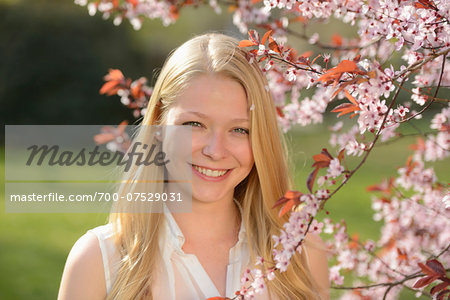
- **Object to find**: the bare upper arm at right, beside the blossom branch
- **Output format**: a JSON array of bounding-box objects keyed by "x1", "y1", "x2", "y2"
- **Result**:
[{"x1": 304, "y1": 233, "x2": 330, "y2": 299}]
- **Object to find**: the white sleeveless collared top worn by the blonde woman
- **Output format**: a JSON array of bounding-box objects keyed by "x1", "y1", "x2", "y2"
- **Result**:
[{"x1": 88, "y1": 204, "x2": 274, "y2": 300}]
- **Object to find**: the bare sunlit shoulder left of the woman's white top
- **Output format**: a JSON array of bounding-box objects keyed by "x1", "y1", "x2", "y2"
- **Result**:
[{"x1": 58, "y1": 232, "x2": 106, "y2": 300}]
